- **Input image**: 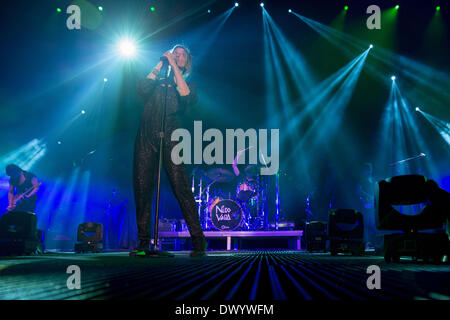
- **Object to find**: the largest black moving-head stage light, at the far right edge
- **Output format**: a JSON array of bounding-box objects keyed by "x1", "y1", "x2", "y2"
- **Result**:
[{"x1": 374, "y1": 174, "x2": 448, "y2": 263}]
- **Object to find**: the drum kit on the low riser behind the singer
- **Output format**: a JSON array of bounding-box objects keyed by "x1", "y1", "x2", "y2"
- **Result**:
[{"x1": 192, "y1": 165, "x2": 268, "y2": 231}]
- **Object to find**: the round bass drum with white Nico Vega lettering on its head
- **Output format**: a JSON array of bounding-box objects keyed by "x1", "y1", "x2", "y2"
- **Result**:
[{"x1": 209, "y1": 199, "x2": 244, "y2": 231}]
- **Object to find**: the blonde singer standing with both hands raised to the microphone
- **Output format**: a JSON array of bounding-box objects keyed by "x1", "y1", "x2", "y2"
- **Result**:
[{"x1": 132, "y1": 45, "x2": 207, "y2": 257}]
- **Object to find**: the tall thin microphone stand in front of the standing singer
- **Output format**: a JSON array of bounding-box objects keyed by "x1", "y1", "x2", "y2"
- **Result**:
[{"x1": 145, "y1": 65, "x2": 175, "y2": 257}]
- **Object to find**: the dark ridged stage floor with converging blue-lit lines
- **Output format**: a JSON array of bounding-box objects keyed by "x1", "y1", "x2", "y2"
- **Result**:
[{"x1": 0, "y1": 250, "x2": 450, "y2": 301}]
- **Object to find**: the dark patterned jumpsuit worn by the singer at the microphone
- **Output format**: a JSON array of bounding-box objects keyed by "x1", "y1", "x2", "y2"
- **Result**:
[{"x1": 133, "y1": 78, "x2": 204, "y2": 249}]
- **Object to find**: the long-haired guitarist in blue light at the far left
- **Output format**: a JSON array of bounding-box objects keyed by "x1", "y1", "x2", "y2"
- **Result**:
[{"x1": 6, "y1": 164, "x2": 41, "y2": 212}]
